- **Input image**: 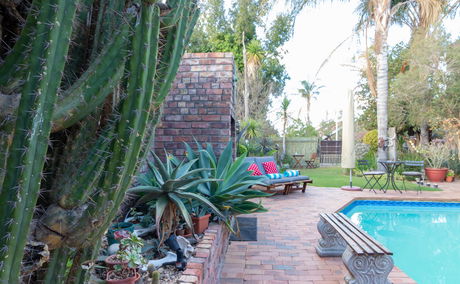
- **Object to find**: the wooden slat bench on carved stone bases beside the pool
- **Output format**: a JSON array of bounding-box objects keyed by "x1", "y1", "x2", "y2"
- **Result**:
[{"x1": 316, "y1": 213, "x2": 393, "y2": 284}]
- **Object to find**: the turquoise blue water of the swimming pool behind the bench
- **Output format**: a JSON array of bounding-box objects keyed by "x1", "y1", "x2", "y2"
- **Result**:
[{"x1": 342, "y1": 200, "x2": 460, "y2": 284}]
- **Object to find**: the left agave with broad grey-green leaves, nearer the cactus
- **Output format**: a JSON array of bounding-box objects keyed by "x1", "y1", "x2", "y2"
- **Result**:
[{"x1": 128, "y1": 152, "x2": 224, "y2": 244}]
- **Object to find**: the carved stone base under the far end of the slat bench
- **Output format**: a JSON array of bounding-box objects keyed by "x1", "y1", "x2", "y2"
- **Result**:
[{"x1": 316, "y1": 214, "x2": 347, "y2": 257}]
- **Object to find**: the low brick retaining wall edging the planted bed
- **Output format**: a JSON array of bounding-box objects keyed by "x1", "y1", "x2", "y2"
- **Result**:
[{"x1": 178, "y1": 223, "x2": 230, "y2": 284}]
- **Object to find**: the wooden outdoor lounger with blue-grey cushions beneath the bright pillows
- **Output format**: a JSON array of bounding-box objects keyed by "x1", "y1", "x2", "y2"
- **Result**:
[{"x1": 245, "y1": 156, "x2": 313, "y2": 195}]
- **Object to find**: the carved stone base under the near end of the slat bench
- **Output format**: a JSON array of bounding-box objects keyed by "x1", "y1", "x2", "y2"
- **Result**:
[{"x1": 342, "y1": 247, "x2": 393, "y2": 284}]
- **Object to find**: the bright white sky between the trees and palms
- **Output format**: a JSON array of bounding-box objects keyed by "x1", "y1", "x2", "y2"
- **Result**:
[{"x1": 268, "y1": 0, "x2": 460, "y2": 130}]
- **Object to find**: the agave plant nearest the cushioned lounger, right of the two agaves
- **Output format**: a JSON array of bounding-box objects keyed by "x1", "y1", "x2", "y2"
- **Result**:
[{"x1": 185, "y1": 142, "x2": 272, "y2": 222}]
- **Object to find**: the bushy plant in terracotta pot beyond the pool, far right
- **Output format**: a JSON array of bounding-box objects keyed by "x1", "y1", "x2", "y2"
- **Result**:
[{"x1": 417, "y1": 140, "x2": 450, "y2": 182}]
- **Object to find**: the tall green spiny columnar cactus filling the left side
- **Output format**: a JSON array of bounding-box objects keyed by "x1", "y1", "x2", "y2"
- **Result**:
[{"x1": 0, "y1": 0, "x2": 198, "y2": 283}]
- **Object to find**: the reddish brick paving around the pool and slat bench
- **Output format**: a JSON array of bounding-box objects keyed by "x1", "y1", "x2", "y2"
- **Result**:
[{"x1": 220, "y1": 181, "x2": 460, "y2": 284}]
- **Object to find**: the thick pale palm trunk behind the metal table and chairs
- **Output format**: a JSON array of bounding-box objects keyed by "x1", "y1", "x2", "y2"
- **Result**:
[{"x1": 374, "y1": 0, "x2": 390, "y2": 165}]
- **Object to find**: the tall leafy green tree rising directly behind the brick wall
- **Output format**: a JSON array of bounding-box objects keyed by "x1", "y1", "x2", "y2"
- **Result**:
[{"x1": 188, "y1": 0, "x2": 292, "y2": 124}]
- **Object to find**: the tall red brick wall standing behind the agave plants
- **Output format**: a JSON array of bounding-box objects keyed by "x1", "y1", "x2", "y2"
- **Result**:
[{"x1": 154, "y1": 53, "x2": 235, "y2": 160}]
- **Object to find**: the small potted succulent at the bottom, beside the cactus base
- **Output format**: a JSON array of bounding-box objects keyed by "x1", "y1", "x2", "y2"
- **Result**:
[{"x1": 106, "y1": 235, "x2": 146, "y2": 284}]
